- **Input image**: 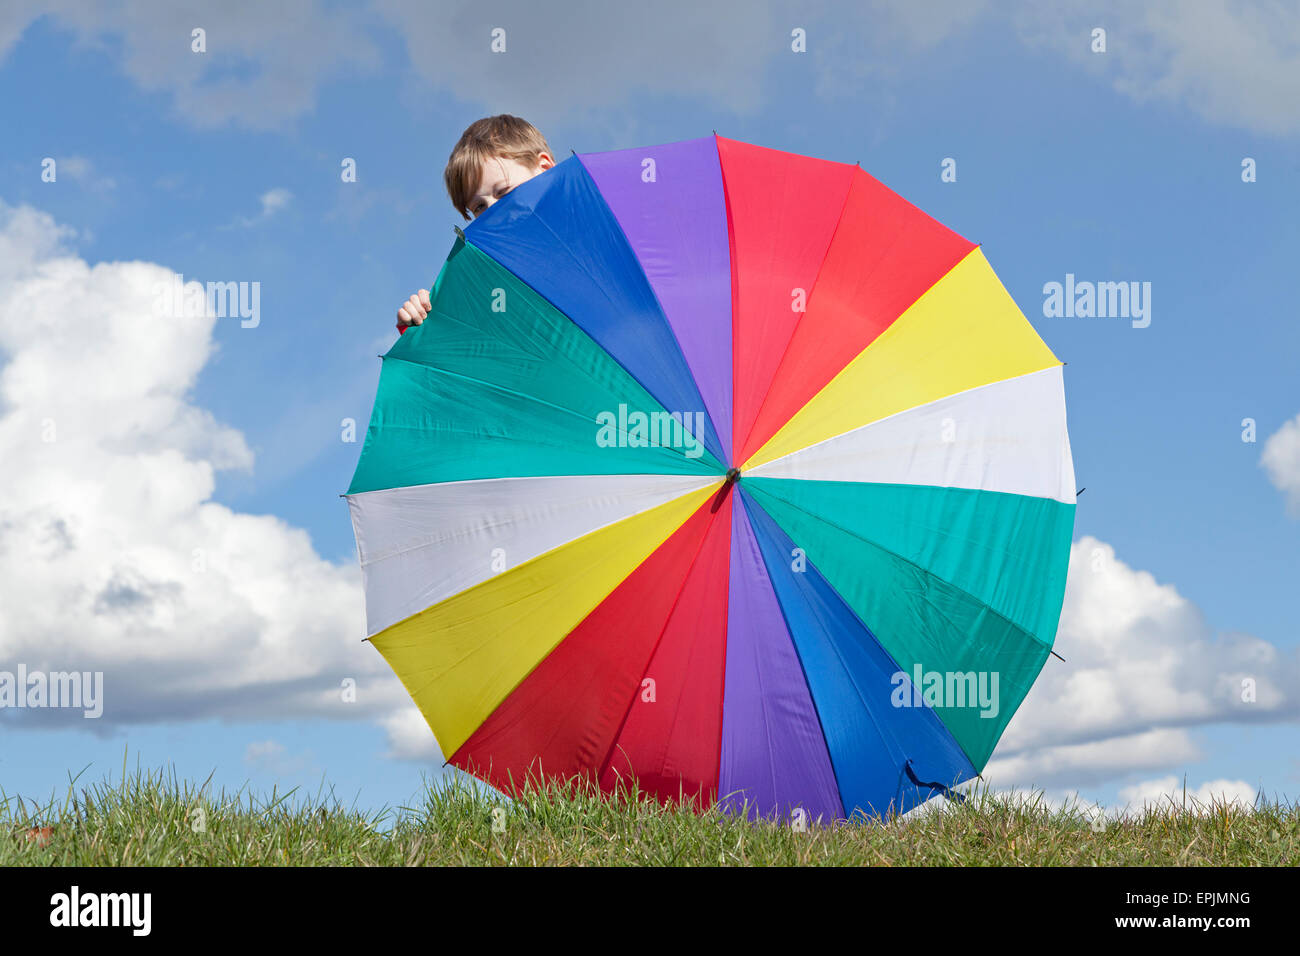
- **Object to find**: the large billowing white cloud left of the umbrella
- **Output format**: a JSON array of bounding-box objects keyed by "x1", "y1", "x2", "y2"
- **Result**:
[{"x1": 0, "y1": 203, "x2": 410, "y2": 731}]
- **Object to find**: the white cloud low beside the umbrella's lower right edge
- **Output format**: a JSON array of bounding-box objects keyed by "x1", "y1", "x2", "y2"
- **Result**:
[{"x1": 985, "y1": 536, "x2": 1300, "y2": 786}]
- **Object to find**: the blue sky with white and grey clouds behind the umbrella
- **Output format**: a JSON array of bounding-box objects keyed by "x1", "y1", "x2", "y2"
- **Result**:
[{"x1": 0, "y1": 0, "x2": 1300, "y2": 810}]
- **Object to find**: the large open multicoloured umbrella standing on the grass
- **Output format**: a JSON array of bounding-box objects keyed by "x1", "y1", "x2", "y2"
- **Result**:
[{"x1": 347, "y1": 135, "x2": 1075, "y2": 819}]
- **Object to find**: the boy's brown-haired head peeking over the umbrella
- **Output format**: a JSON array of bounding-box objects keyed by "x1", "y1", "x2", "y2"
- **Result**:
[{"x1": 442, "y1": 113, "x2": 555, "y2": 220}]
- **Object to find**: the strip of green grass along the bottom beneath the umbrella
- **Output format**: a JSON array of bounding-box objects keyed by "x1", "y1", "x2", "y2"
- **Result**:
[{"x1": 0, "y1": 766, "x2": 1300, "y2": 866}]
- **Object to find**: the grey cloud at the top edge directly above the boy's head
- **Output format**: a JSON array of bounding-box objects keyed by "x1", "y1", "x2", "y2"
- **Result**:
[{"x1": 374, "y1": 0, "x2": 774, "y2": 138}]
